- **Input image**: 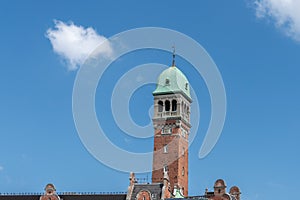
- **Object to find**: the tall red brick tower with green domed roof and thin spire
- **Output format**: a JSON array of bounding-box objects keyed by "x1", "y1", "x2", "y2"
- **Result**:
[{"x1": 152, "y1": 54, "x2": 192, "y2": 196}]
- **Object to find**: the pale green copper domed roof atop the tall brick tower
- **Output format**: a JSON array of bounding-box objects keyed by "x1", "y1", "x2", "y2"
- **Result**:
[{"x1": 153, "y1": 66, "x2": 192, "y2": 99}]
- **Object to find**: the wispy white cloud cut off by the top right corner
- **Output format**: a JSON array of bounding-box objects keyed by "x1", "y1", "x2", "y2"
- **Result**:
[{"x1": 254, "y1": 0, "x2": 300, "y2": 42}]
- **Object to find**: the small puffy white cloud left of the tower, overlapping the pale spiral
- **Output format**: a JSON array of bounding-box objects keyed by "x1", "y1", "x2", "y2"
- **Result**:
[{"x1": 46, "y1": 20, "x2": 113, "y2": 70}]
